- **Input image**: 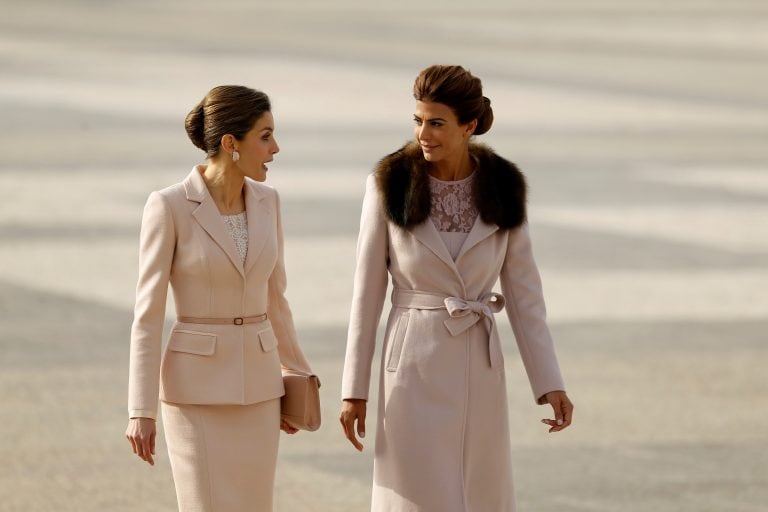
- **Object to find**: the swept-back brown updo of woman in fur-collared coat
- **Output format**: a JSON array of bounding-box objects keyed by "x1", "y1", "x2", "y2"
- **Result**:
[{"x1": 413, "y1": 65, "x2": 493, "y2": 135}]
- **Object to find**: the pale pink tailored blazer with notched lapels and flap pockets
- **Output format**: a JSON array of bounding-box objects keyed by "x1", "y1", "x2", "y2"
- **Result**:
[{"x1": 128, "y1": 167, "x2": 311, "y2": 418}]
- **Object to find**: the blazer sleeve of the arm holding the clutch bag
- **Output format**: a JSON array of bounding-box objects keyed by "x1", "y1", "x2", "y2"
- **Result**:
[{"x1": 267, "y1": 191, "x2": 312, "y2": 373}]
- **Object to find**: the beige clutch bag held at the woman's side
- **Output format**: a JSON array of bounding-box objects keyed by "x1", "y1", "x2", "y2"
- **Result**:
[{"x1": 280, "y1": 370, "x2": 320, "y2": 432}]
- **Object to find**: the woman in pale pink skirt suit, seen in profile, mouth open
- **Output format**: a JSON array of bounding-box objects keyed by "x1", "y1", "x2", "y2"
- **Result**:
[{"x1": 126, "y1": 85, "x2": 312, "y2": 512}]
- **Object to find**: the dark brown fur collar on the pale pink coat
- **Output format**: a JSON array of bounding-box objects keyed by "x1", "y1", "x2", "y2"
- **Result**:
[{"x1": 374, "y1": 142, "x2": 527, "y2": 229}]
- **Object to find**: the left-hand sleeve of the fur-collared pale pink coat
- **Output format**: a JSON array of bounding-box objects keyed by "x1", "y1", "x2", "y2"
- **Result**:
[{"x1": 341, "y1": 175, "x2": 389, "y2": 400}]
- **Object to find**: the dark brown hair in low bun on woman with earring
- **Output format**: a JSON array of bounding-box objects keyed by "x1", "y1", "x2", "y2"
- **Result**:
[{"x1": 184, "y1": 85, "x2": 272, "y2": 158}]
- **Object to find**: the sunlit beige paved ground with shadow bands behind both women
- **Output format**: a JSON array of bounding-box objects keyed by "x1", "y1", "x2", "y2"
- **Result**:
[{"x1": 0, "y1": 0, "x2": 768, "y2": 512}]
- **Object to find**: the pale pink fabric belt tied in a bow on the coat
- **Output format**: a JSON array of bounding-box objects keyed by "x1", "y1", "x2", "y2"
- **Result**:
[{"x1": 392, "y1": 288, "x2": 505, "y2": 370}]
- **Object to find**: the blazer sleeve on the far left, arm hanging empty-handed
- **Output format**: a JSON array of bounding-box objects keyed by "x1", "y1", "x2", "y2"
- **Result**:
[{"x1": 128, "y1": 192, "x2": 176, "y2": 418}]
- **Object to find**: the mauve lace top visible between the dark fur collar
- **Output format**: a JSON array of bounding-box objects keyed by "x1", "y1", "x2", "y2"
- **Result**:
[{"x1": 429, "y1": 172, "x2": 478, "y2": 259}]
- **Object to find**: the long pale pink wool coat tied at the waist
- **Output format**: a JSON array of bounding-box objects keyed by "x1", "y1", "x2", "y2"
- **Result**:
[{"x1": 342, "y1": 145, "x2": 565, "y2": 512}]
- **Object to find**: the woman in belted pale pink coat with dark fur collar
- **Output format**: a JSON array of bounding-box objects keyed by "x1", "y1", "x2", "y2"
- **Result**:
[{"x1": 340, "y1": 66, "x2": 573, "y2": 512}]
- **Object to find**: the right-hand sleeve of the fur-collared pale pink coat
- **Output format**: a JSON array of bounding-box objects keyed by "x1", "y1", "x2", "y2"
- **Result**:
[{"x1": 501, "y1": 223, "x2": 565, "y2": 404}]
